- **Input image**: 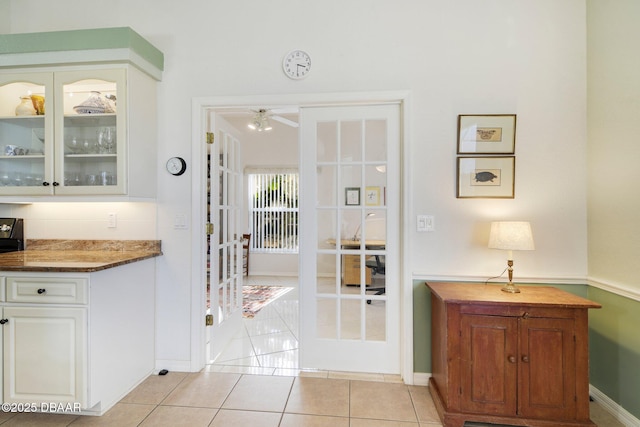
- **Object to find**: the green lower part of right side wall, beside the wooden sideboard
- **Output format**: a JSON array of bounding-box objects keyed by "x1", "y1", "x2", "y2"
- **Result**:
[{"x1": 588, "y1": 287, "x2": 640, "y2": 418}]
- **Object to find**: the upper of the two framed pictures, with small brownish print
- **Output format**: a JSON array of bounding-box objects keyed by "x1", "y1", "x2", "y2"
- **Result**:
[{"x1": 458, "y1": 114, "x2": 516, "y2": 154}]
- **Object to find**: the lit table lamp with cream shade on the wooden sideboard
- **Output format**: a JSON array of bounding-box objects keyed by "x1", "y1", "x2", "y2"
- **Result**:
[{"x1": 489, "y1": 221, "x2": 535, "y2": 293}]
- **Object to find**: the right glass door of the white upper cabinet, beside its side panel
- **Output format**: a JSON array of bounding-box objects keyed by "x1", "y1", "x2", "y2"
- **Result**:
[{"x1": 55, "y1": 70, "x2": 126, "y2": 194}]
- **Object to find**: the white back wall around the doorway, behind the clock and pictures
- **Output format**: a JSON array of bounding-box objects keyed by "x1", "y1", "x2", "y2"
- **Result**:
[{"x1": 0, "y1": 0, "x2": 587, "y2": 365}]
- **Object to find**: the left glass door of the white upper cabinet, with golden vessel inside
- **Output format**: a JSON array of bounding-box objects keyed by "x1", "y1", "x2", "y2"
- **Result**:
[{"x1": 0, "y1": 73, "x2": 53, "y2": 195}]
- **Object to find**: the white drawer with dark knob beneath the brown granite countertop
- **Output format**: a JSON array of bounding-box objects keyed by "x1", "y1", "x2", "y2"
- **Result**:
[{"x1": 6, "y1": 277, "x2": 88, "y2": 304}]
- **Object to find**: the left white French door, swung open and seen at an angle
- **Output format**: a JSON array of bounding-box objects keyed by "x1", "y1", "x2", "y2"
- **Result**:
[{"x1": 206, "y1": 118, "x2": 243, "y2": 362}]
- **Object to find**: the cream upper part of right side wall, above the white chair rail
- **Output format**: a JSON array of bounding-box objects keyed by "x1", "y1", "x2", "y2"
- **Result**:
[{"x1": 588, "y1": 0, "x2": 640, "y2": 295}]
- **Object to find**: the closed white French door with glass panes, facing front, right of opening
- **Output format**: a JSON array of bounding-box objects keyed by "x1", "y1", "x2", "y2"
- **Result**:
[{"x1": 300, "y1": 104, "x2": 401, "y2": 373}]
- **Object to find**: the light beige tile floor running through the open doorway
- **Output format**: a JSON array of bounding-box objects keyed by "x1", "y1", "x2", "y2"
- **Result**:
[{"x1": 0, "y1": 278, "x2": 624, "y2": 427}]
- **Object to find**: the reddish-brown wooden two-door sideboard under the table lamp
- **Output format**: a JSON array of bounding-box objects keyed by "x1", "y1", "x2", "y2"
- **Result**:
[{"x1": 426, "y1": 283, "x2": 600, "y2": 427}]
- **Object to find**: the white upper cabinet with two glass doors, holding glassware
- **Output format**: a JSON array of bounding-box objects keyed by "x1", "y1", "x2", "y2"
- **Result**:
[{"x1": 0, "y1": 29, "x2": 162, "y2": 203}]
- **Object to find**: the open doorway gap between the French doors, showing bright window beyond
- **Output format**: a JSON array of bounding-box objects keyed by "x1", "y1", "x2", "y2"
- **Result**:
[{"x1": 207, "y1": 106, "x2": 299, "y2": 375}]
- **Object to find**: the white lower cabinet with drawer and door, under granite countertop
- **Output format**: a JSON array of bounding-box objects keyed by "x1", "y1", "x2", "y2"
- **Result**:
[{"x1": 0, "y1": 260, "x2": 155, "y2": 415}]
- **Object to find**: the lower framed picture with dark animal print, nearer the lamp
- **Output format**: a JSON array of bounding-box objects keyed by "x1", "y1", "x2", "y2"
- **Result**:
[{"x1": 456, "y1": 156, "x2": 516, "y2": 199}]
